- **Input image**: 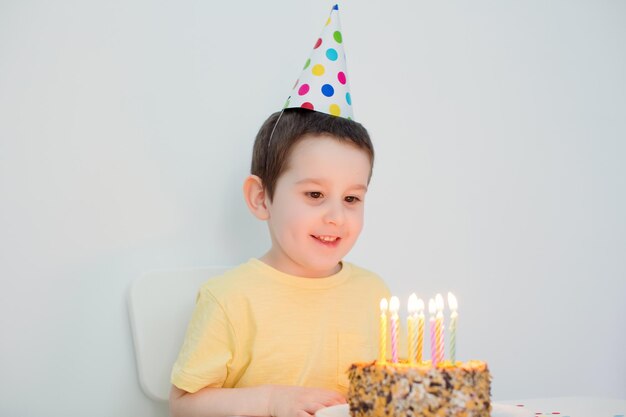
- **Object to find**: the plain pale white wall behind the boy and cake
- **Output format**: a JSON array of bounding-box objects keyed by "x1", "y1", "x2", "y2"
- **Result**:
[{"x1": 0, "y1": 0, "x2": 626, "y2": 417}]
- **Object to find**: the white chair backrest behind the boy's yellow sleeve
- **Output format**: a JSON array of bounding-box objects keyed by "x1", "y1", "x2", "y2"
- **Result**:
[{"x1": 128, "y1": 267, "x2": 229, "y2": 401}]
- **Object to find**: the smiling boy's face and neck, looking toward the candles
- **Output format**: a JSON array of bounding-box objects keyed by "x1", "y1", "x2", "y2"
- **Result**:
[{"x1": 264, "y1": 136, "x2": 371, "y2": 277}]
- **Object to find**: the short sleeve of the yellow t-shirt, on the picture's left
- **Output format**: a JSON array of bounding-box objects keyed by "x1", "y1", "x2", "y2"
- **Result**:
[{"x1": 171, "y1": 285, "x2": 235, "y2": 393}]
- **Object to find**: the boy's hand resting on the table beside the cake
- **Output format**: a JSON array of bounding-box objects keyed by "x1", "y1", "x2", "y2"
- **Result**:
[{"x1": 269, "y1": 386, "x2": 346, "y2": 417}]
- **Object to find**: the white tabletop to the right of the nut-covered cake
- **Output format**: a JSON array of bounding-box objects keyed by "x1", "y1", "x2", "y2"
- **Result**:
[{"x1": 496, "y1": 397, "x2": 626, "y2": 417}]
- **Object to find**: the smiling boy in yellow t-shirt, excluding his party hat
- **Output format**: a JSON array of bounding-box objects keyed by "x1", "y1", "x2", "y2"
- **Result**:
[{"x1": 170, "y1": 8, "x2": 389, "y2": 417}]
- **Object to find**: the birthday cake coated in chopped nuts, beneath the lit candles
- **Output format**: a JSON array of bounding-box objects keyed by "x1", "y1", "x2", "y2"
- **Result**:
[{"x1": 348, "y1": 361, "x2": 491, "y2": 417}]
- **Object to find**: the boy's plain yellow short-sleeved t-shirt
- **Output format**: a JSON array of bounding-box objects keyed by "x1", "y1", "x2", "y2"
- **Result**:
[{"x1": 171, "y1": 259, "x2": 389, "y2": 394}]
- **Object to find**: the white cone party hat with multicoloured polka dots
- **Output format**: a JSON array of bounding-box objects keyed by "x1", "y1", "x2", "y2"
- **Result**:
[{"x1": 285, "y1": 5, "x2": 353, "y2": 119}]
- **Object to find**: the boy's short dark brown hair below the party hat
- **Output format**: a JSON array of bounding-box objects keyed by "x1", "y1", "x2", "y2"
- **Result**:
[{"x1": 250, "y1": 108, "x2": 374, "y2": 201}]
